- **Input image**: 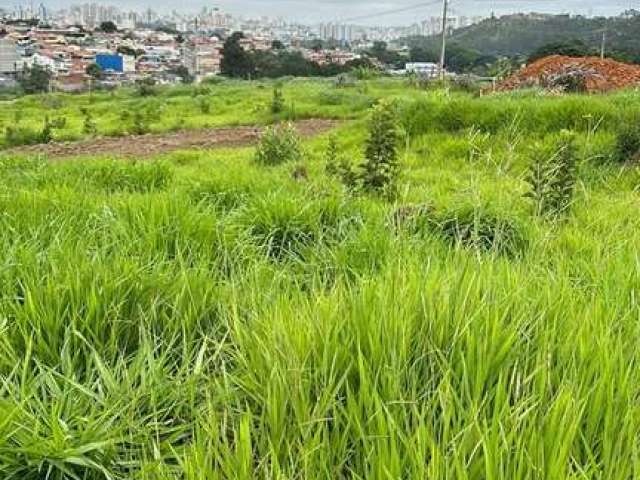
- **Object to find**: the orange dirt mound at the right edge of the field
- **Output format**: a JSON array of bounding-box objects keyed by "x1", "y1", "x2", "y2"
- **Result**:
[{"x1": 498, "y1": 55, "x2": 640, "y2": 92}]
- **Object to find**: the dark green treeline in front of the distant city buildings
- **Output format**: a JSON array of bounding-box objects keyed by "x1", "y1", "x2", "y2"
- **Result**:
[{"x1": 221, "y1": 32, "x2": 373, "y2": 79}]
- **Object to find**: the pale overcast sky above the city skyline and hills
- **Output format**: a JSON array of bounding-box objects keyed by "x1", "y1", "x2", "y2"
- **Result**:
[{"x1": 22, "y1": 0, "x2": 640, "y2": 25}]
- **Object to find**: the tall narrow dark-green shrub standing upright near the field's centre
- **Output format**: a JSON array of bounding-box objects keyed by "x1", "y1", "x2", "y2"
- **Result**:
[{"x1": 359, "y1": 101, "x2": 400, "y2": 196}]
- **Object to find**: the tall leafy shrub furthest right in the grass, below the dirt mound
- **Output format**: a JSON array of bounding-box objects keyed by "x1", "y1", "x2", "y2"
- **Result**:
[{"x1": 525, "y1": 132, "x2": 577, "y2": 216}]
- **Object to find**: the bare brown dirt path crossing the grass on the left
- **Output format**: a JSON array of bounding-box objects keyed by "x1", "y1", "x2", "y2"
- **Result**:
[{"x1": 0, "y1": 120, "x2": 339, "y2": 158}]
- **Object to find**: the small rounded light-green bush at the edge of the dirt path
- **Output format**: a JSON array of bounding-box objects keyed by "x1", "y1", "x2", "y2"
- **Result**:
[{"x1": 255, "y1": 123, "x2": 303, "y2": 166}]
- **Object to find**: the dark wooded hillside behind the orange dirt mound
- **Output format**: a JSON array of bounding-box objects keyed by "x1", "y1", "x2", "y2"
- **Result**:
[{"x1": 406, "y1": 11, "x2": 640, "y2": 60}]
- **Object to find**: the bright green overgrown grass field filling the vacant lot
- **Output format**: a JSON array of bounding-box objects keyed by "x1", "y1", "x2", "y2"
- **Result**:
[{"x1": 0, "y1": 81, "x2": 640, "y2": 480}]
